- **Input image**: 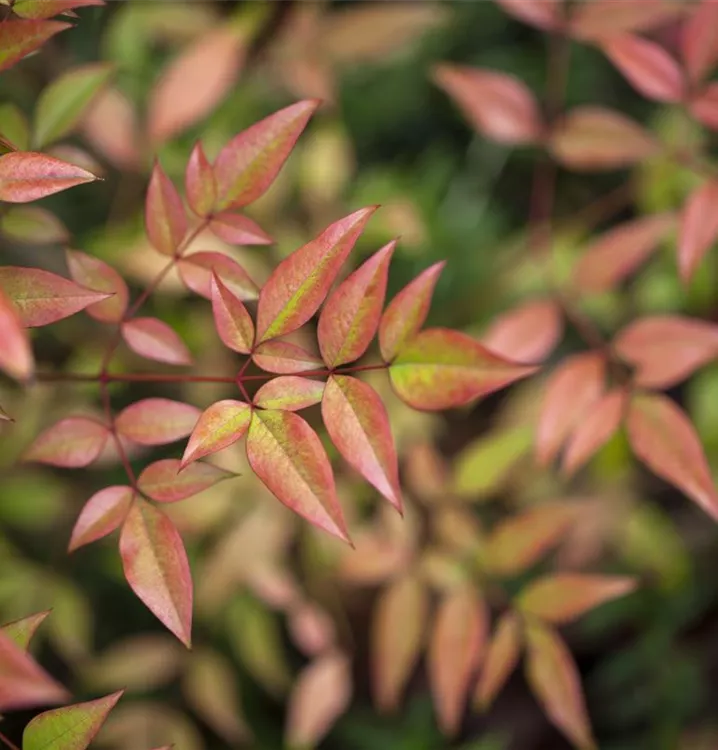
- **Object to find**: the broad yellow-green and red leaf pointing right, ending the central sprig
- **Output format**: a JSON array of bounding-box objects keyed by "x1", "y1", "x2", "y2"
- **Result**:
[{"x1": 389, "y1": 328, "x2": 536, "y2": 411}]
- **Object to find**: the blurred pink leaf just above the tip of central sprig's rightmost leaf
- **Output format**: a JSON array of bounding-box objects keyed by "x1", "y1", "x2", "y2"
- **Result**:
[{"x1": 481, "y1": 300, "x2": 563, "y2": 363}]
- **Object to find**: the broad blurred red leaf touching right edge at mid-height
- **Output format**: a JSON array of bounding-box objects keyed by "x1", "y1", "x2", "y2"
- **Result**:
[{"x1": 613, "y1": 315, "x2": 718, "y2": 388}]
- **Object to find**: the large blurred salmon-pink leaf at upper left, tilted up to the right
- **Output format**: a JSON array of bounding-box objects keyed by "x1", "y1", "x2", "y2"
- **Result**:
[{"x1": 147, "y1": 28, "x2": 244, "y2": 145}]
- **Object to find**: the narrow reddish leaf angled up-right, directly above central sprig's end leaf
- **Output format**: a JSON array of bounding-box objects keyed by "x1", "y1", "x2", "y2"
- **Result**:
[{"x1": 379, "y1": 261, "x2": 446, "y2": 362}]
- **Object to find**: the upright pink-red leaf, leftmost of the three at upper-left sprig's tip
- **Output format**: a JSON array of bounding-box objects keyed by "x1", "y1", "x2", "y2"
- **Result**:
[{"x1": 145, "y1": 162, "x2": 187, "y2": 255}]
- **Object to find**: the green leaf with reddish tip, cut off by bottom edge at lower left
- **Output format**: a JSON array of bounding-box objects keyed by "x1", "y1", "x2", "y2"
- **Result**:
[{"x1": 22, "y1": 690, "x2": 124, "y2": 750}]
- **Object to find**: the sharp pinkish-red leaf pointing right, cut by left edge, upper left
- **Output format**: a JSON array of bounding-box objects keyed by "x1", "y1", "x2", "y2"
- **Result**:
[{"x1": 0, "y1": 151, "x2": 97, "y2": 203}]
